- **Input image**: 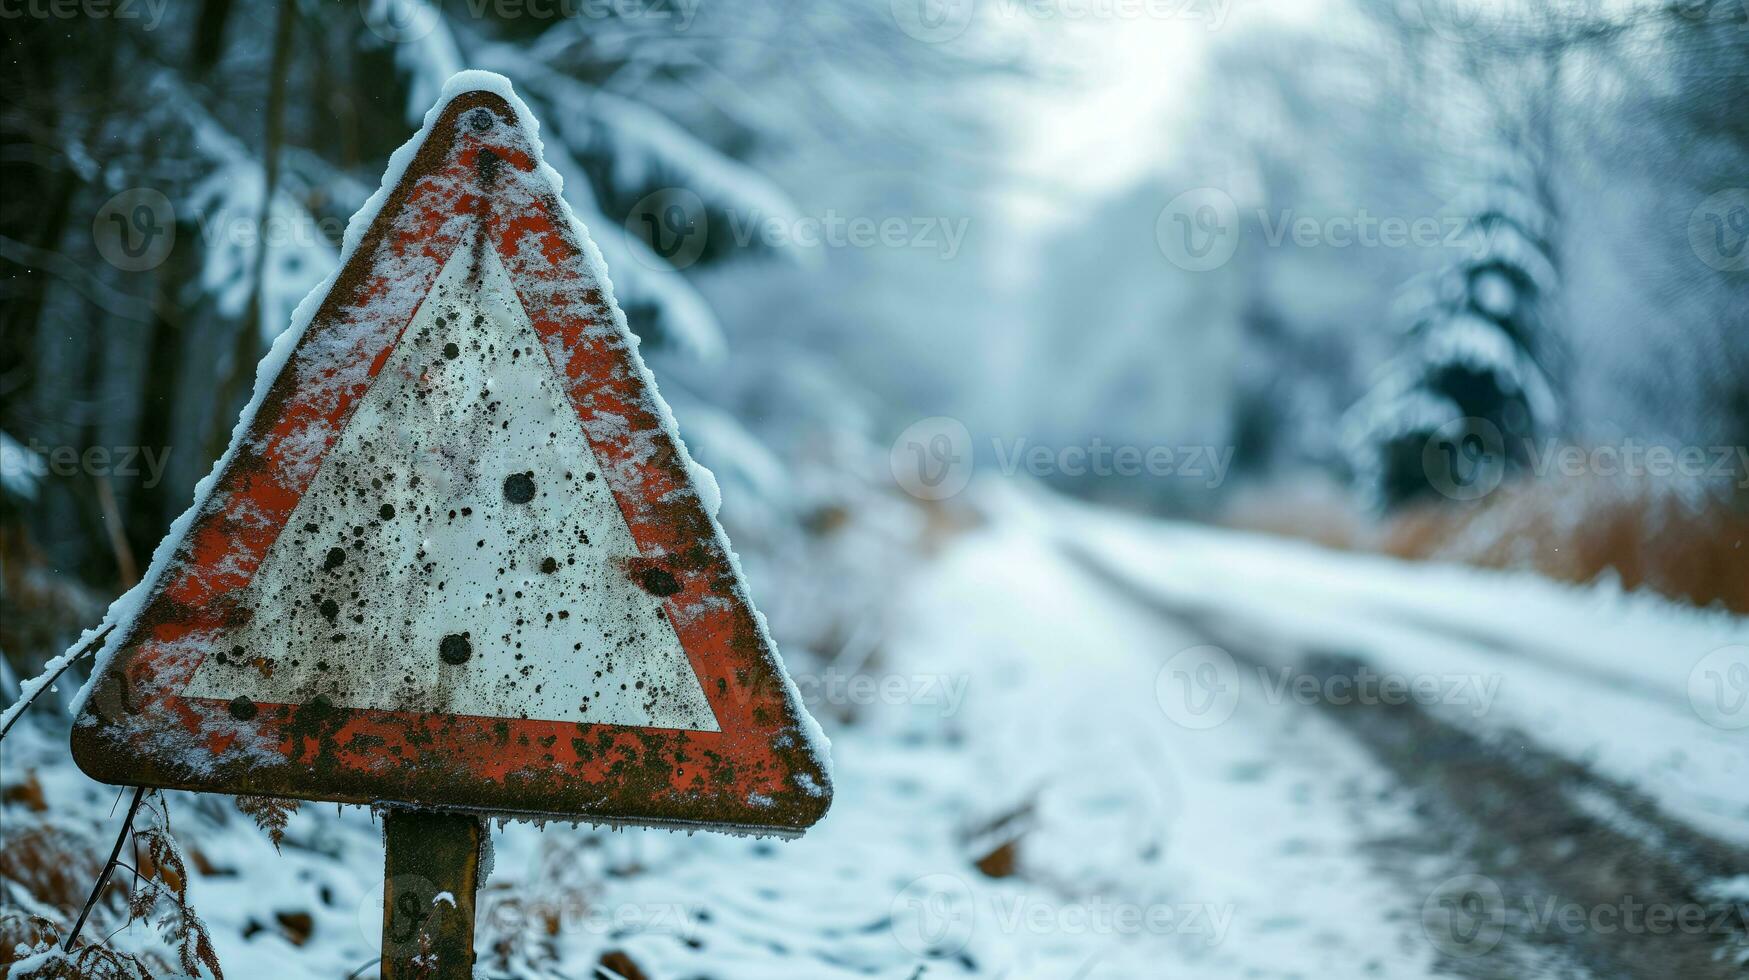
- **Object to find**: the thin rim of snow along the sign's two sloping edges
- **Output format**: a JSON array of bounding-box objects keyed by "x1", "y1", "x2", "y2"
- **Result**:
[{"x1": 66, "y1": 70, "x2": 831, "y2": 795}]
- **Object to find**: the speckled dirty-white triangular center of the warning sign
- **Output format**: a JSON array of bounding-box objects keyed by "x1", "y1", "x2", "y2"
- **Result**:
[{"x1": 184, "y1": 247, "x2": 717, "y2": 732}]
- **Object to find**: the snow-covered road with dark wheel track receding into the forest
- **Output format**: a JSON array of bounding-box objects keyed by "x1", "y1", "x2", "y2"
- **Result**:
[{"x1": 1051, "y1": 497, "x2": 1749, "y2": 977}]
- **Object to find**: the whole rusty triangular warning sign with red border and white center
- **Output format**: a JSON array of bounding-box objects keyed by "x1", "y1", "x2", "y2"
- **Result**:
[{"x1": 73, "y1": 75, "x2": 831, "y2": 833}]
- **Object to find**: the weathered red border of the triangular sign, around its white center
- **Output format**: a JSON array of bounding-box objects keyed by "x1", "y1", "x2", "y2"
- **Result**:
[{"x1": 72, "y1": 82, "x2": 831, "y2": 835}]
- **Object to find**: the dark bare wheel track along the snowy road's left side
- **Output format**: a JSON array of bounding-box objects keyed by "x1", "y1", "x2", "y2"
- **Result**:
[{"x1": 1065, "y1": 548, "x2": 1749, "y2": 980}]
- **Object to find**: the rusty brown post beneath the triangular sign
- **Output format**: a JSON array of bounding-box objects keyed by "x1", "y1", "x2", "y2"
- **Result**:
[{"x1": 380, "y1": 810, "x2": 484, "y2": 980}]
